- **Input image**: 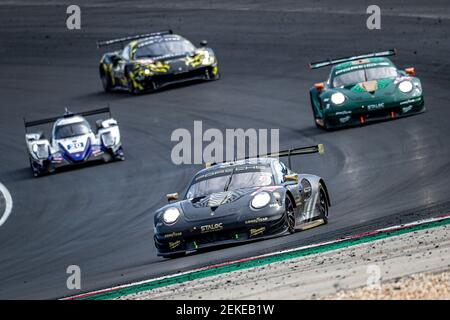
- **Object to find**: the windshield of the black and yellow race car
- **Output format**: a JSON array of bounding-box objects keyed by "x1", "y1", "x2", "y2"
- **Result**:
[{"x1": 134, "y1": 39, "x2": 195, "y2": 59}]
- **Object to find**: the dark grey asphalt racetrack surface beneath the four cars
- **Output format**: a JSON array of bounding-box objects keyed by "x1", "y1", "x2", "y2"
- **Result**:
[{"x1": 0, "y1": 0, "x2": 450, "y2": 299}]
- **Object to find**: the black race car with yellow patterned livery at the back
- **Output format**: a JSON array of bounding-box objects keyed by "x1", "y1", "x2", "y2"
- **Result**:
[{"x1": 97, "y1": 30, "x2": 219, "y2": 94}]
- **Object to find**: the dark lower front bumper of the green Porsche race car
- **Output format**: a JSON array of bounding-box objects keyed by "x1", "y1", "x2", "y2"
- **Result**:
[{"x1": 324, "y1": 96, "x2": 425, "y2": 128}]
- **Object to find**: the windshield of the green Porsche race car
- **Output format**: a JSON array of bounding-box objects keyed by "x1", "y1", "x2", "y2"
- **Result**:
[{"x1": 333, "y1": 67, "x2": 397, "y2": 88}]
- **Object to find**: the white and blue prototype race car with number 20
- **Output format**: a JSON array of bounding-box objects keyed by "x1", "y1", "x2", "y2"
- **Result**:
[{"x1": 24, "y1": 107, "x2": 125, "y2": 177}]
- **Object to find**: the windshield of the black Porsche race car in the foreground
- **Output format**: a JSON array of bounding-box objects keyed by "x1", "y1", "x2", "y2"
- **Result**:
[{"x1": 186, "y1": 167, "x2": 273, "y2": 199}]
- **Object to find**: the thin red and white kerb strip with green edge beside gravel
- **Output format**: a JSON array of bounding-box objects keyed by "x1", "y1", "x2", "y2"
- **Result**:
[{"x1": 61, "y1": 214, "x2": 450, "y2": 300}]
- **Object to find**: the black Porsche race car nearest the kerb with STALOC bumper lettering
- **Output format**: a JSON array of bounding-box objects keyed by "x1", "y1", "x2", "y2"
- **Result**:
[{"x1": 154, "y1": 145, "x2": 330, "y2": 257}]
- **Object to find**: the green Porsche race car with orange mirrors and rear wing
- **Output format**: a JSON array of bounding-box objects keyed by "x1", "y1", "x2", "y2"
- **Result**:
[{"x1": 310, "y1": 49, "x2": 425, "y2": 130}]
